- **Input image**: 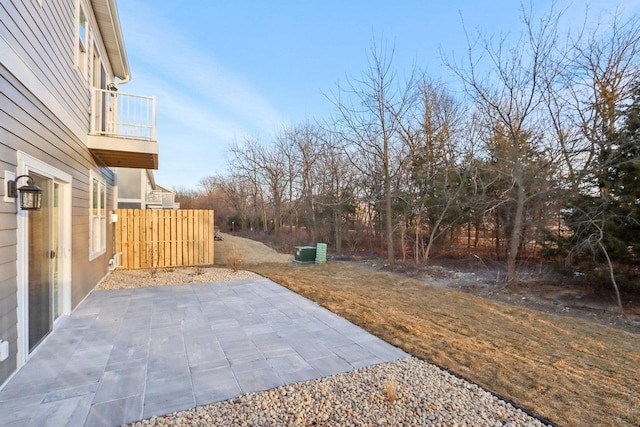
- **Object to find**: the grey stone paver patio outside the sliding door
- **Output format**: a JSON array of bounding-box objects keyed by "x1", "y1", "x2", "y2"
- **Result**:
[{"x1": 0, "y1": 279, "x2": 408, "y2": 426}]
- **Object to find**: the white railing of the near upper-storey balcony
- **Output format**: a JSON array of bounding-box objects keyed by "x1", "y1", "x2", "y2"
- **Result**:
[{"x1": 91, "y1": 88, "x2": 157, "y2": 141}]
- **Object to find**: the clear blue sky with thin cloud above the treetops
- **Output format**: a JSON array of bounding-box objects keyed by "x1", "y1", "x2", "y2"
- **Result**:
[{"x1": 118, "y1": 0, "x2": 640, "y2": 189}]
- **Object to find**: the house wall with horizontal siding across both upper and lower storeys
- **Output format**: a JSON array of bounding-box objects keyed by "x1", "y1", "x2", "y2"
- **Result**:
[{"x1": 0, "y1": 0, "x2": 120, "y2": 384}]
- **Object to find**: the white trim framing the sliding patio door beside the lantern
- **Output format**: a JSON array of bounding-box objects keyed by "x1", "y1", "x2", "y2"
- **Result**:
[{"x1": 16, "y1": 151, "x2": 72, "y2": 368}]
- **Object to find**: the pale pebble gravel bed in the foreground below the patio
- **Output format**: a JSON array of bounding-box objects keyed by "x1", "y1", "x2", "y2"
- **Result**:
[{"x1": 129, "y1": 357, "x2": 544, "y2": 427}]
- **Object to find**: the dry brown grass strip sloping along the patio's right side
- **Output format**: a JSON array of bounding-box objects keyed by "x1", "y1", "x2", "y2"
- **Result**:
[{"x1": 249, "y1": 263, "x2": 640, "y2": 427}]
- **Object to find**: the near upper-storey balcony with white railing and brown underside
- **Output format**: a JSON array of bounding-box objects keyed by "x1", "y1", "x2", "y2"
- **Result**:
[{"x1": 87, "y1": 88, "x2": 158, "y2": 169}]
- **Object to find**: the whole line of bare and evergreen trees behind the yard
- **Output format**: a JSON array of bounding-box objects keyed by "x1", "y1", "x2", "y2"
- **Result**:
[{"x1": 183, "y1": 8, "x2": 640, "y2": 296}]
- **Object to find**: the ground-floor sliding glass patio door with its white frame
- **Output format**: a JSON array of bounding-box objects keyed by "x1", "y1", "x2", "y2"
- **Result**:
[{"x1": 15, "y1": 151, "x2": 73, "y2": 366}]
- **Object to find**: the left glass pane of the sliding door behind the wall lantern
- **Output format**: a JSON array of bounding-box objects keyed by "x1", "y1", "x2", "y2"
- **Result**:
[{"x1": 28, "y1": 173, "x2": 52, "y2": 351}]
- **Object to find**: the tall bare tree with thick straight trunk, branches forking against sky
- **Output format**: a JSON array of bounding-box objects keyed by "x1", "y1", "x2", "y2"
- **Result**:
[{"x1": 448, "y1": 3, "x2": 561, "y2": 288}]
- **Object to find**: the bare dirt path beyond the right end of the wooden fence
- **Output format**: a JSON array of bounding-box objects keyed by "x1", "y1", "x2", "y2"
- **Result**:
[{"x1": 214, "y1": 233, "x2": 293, "y2": 265}]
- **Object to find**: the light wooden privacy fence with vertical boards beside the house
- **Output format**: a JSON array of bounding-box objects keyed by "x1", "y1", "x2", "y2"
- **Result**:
[{"x1": 115, "y1": 209, "x2": 214, "y2": 269}]
